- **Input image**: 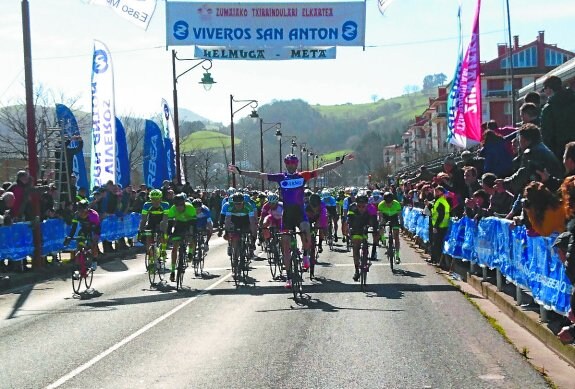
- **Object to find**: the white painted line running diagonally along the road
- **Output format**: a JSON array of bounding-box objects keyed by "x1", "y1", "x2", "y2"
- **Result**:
[{"x1": 46, "y1": 273, "x2": 232, "y2": 389}]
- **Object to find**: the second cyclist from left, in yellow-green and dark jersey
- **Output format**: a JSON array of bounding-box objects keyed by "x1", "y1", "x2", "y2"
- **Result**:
[{"x1": 138, "y1": 189, "x2": 170, "y2": 260}]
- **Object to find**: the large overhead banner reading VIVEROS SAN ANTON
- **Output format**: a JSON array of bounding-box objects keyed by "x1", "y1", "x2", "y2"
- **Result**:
[{"x1": 166, "y1": 1, "x2": 365, "y2": 48}]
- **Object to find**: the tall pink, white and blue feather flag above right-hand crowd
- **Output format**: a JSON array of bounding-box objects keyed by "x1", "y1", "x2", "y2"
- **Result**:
[{"x1": 450, "y1": 0, "x2": 481, "y2": 148}]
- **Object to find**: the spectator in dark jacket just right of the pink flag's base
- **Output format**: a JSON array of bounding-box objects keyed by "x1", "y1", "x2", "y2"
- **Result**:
[{"x1": 479, "y1": 130, "x2": 513, "y2": 178}]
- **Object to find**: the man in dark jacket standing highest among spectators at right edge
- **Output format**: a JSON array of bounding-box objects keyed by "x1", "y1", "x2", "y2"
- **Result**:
[{"x1": 541, "y1": 76, "x2": 575, "y2": 159}]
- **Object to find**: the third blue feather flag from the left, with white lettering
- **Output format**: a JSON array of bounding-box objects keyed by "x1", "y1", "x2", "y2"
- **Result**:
[{"x1": 143, "y1": 120, "x2": 166, "y2": 188}]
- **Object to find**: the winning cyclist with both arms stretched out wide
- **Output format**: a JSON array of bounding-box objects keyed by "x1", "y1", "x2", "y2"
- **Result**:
[{"x1": 228, "y1": 154, "x2": 353, "y2": 288}]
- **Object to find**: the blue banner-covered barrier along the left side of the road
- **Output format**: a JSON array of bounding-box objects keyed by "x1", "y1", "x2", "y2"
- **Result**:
[{"x1": 0, "y1": 213, "x2": 142, "y2": 261}]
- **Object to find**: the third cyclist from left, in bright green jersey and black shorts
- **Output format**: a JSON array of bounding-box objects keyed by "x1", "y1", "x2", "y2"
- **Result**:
[{"x1": 168, "y1": 193, "x2": 196, "y2": 282}]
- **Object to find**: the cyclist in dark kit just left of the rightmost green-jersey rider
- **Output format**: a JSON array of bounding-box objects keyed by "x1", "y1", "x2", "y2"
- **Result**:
[{"x1": 347, "y1": 194, "x2": 377, "y2": 281}]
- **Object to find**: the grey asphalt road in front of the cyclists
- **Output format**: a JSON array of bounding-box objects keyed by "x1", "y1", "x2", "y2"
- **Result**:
[{"x1": 0, "y1": 238, "x2": 547, "y2": 388}]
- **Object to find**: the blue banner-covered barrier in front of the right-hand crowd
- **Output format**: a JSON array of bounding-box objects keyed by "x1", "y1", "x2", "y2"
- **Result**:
[{"x1": 403, "y1": 207, "x2": 573, "y2": 315}]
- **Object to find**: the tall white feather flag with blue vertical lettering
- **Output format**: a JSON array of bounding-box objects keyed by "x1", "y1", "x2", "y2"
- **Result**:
[{"x1": 90, "y1": 40, "x2": 116, "y2": 186}]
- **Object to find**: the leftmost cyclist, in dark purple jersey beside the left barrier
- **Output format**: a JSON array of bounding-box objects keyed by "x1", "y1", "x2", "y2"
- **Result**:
[{"x1": 64, "y1": 200, "x2": 100, "y2": 270}]
